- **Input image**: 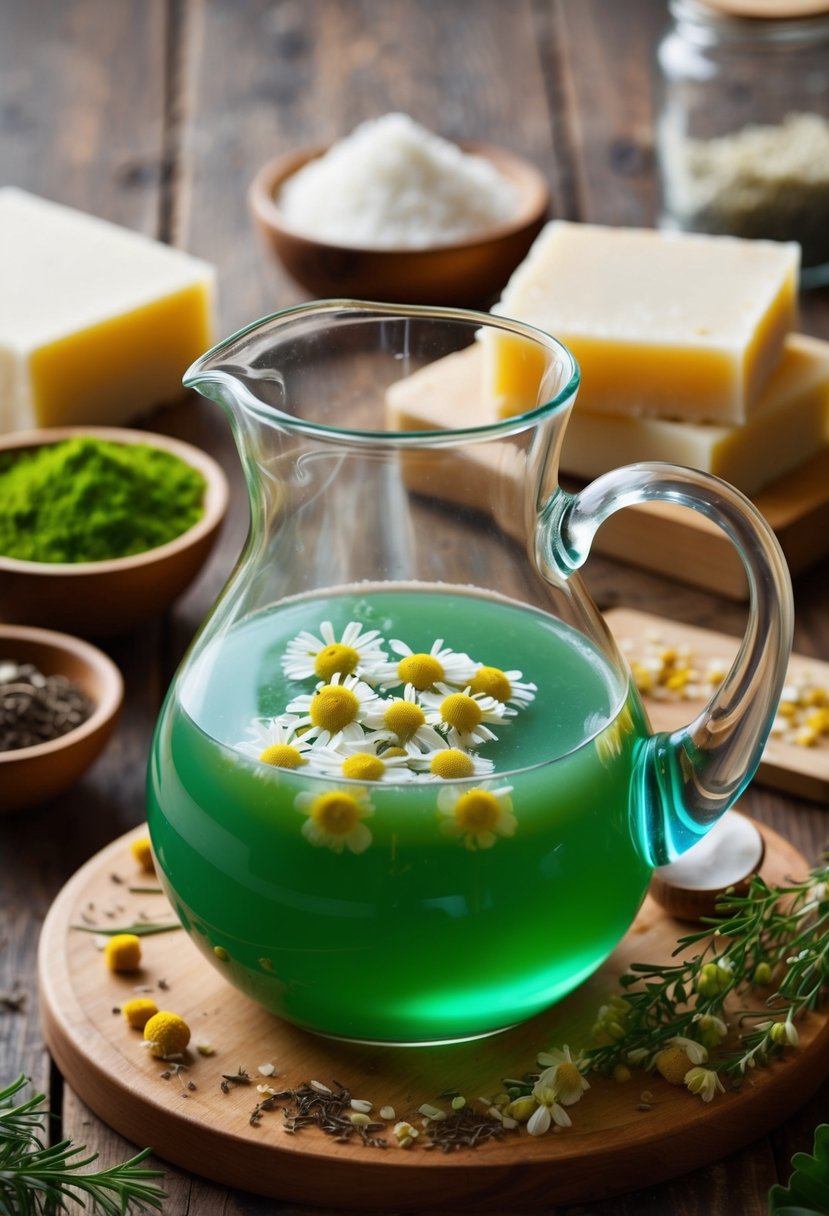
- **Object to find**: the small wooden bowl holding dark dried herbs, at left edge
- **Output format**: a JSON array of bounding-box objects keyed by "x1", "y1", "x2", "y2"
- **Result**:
[{"x1": 0, "y1": 625, "x2": 124, "y2": 814}]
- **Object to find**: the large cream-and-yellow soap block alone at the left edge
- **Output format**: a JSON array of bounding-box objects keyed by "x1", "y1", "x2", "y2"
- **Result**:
[{"x1": 0, "y1": 187, "x2": 215, "y2": 430}]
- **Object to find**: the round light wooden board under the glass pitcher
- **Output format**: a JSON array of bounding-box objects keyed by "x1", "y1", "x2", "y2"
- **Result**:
[{"x1": 39, "y1": 828, "x2": 829, "y2": 1211}]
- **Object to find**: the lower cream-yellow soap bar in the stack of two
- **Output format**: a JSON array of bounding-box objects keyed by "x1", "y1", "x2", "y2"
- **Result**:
[{"x1": 562, "y1": 334, "x2": 829, "y2": 495}]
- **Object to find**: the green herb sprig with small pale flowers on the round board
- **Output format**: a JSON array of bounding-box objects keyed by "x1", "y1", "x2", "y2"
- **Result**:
[{"x1": 583, "y1": 856, "x2": 829, "y2": 1085}]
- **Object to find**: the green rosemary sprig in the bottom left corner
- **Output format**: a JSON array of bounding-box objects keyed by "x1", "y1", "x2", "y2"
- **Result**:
[{"x1": 0, "y1": 1076, "x2": 167, "y2": 1216}]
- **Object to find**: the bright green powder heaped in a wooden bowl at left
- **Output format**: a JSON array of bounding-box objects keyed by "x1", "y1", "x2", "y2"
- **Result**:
[{"x1": 0, "y1": 435, "x2": 207, "y2": 563}]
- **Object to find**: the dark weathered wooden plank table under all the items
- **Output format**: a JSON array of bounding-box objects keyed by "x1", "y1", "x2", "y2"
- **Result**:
[{"x1": 0, "y1": 0, "x2": 829, "y2": 1216}]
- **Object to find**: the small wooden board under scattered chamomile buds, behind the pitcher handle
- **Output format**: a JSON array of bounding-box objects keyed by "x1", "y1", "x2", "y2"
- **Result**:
[{"x1": 604, "y1": 608, "x2": 829, "y2": 804}]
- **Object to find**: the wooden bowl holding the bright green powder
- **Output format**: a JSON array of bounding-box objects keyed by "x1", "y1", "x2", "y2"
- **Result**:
[{"x1": 0, "y1": 427, "x2": 229, "y2": 637}]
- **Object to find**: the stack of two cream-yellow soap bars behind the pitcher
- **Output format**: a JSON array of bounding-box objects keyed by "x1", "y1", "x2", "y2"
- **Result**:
[{"x1": 484, "y1": 221, "x2": 829, "y2": 494}]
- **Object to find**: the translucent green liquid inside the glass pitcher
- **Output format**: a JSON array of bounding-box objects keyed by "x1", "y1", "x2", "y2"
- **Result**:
[{"x1": 148, "y1": 585, "x2": 649, "y2": 1042}]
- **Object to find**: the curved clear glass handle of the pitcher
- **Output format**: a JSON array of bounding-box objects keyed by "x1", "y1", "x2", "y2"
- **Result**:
[{"x1": 537, "y1": 462, "x2": 794, "y2": 866}]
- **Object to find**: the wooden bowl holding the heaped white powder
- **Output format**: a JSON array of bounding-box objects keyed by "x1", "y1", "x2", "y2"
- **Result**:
[{"x1": 248, "y1": 142, "x2": 549, "y2": 308}]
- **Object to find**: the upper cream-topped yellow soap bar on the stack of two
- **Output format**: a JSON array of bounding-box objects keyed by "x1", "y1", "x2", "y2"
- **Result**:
[{"x1": 486, "y1": 220, "x2": 800, "y2": 423}]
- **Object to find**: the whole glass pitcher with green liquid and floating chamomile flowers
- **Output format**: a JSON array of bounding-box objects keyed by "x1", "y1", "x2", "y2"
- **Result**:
[{"x1": 148, "y1": 300, "x2": 791, "y2": 1043}]
